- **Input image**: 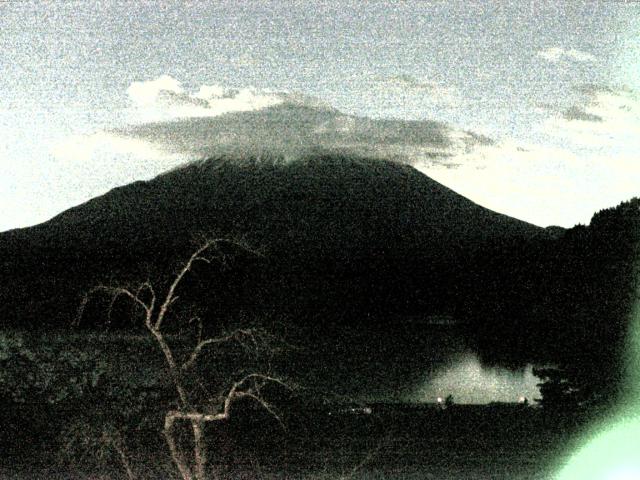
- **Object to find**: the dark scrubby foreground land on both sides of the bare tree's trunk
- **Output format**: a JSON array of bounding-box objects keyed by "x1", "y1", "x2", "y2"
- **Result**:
[{"x1": 0, "y1": 331, "x2": 579, "y2": 480}]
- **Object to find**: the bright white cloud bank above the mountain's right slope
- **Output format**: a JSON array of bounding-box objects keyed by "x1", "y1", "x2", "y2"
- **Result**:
[{"x1": 416, "y1": 85, "x2": 640, "y2": 227}]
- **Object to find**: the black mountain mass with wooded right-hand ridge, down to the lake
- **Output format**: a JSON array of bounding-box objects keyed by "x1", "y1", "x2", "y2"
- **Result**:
[{"x1": 0, "y1": 155, "x2": 639, "y2": 398}]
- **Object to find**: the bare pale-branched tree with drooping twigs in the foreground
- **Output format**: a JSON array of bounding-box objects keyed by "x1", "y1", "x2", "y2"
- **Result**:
[{"x1": 78, "y1": 238, "x2": 288, "y2": 480}]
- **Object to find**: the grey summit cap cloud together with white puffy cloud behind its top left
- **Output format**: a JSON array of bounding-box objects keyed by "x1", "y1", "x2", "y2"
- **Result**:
[{"x1": 110, "y1": 75, "x2": 484, "y2": 169}]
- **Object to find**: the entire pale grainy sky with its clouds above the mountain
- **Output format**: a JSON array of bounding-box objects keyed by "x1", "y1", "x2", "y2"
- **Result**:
[{"x1": 0, "y1": 0, "x2": 640, "y2": 231}]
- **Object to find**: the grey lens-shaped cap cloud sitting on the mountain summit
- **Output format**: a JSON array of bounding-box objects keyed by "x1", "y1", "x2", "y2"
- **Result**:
[{"x1": 112, "y1": 87, "x2": 484, "y2": 165}]
